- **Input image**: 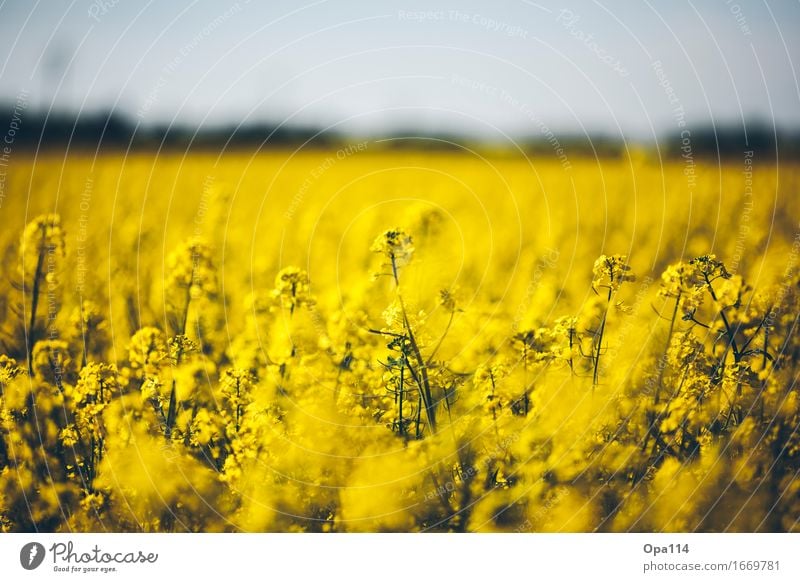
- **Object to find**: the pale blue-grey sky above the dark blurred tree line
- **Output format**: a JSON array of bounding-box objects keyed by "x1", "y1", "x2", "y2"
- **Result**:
[{"x1": 0, "y1": 0, "x2": 800, "y2": 139}]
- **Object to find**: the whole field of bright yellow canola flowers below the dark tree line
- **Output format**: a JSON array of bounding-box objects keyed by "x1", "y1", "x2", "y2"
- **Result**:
[{"x1": 0, "y1": 152, "x2": 800, "y2": 532}]
